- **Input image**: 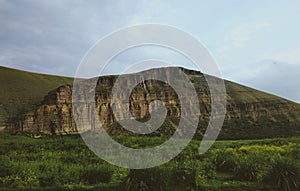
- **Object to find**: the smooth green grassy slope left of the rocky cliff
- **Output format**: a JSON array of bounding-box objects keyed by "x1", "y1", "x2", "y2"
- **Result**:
[{"x1": 0, "y1": 66, "x2": 73, "y2": 127}]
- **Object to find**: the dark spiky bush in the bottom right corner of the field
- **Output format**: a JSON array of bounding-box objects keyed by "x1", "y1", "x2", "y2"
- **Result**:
[{"x1": 264, "y1": 158, "x2": 300, "y2": 191}]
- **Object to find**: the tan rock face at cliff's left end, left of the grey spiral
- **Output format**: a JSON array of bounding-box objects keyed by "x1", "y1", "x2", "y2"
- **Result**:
[{"x1": 22, "y1": 85, "x2": 77, "y2": 133}]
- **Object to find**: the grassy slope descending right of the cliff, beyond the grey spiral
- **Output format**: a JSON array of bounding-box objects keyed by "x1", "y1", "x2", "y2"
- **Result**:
[{"x1": 221, "y1": 81, "x2": 300, "y2": 139}]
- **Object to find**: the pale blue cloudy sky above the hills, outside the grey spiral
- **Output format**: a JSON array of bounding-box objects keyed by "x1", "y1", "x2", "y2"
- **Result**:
[{"x1": 0, "y1": 0, "x2": 300, "y2": 103}]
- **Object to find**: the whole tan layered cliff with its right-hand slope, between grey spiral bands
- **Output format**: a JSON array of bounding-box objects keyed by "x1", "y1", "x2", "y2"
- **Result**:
[{"x1": 20, "y1": 69, "x2": 300, "y2": 138}]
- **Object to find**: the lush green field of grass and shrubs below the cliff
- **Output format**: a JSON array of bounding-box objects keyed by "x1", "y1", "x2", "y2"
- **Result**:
[{"x1": 0, "y1": 132, "x2": 300, "y2": 191}]
